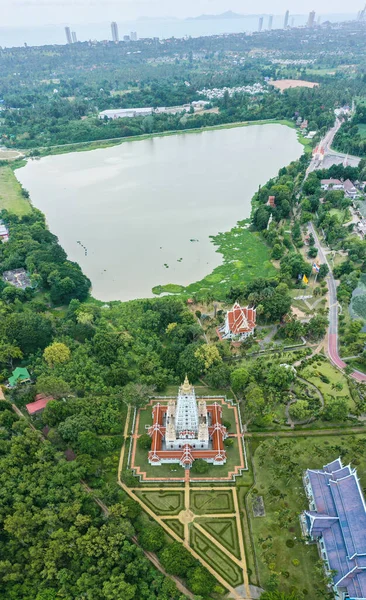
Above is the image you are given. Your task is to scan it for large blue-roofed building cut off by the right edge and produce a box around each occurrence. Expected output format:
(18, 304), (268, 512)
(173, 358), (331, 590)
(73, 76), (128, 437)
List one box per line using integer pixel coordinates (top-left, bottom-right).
(303, 459), (366, 600)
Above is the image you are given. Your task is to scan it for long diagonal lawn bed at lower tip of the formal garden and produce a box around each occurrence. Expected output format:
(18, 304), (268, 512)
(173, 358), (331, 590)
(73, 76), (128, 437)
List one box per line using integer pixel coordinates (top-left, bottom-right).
(190, 524), (243, 587)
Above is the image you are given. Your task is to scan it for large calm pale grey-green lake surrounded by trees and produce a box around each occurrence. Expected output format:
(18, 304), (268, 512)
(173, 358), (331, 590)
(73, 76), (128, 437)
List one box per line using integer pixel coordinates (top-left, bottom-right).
(16, 124), (303, 301)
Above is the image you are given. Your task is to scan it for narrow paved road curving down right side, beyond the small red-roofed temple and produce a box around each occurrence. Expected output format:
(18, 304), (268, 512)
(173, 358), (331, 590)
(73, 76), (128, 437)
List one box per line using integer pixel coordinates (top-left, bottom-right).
(308, 223), (366, 381)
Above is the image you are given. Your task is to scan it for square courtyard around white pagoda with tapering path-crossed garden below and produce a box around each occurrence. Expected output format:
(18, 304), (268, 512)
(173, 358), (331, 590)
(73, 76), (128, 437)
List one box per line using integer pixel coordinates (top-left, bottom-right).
(119, 381), (257, 600)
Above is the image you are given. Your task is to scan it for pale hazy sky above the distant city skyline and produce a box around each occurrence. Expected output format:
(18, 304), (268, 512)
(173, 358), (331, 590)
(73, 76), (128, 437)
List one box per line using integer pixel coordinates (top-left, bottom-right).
(0, 0), (364, 27)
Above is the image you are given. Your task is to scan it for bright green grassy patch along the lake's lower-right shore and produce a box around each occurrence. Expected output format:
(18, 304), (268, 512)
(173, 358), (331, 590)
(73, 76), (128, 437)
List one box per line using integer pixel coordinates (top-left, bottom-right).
(153, 221), (276, 300)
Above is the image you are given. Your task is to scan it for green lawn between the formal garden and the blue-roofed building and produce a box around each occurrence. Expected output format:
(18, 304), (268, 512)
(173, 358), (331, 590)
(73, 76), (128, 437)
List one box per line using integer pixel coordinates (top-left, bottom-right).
(248, 433), (366, 599)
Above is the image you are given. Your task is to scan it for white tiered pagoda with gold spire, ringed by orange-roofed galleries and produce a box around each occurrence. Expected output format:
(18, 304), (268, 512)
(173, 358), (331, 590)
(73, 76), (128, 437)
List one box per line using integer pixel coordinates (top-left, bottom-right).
(148, 377), (227, 469)
